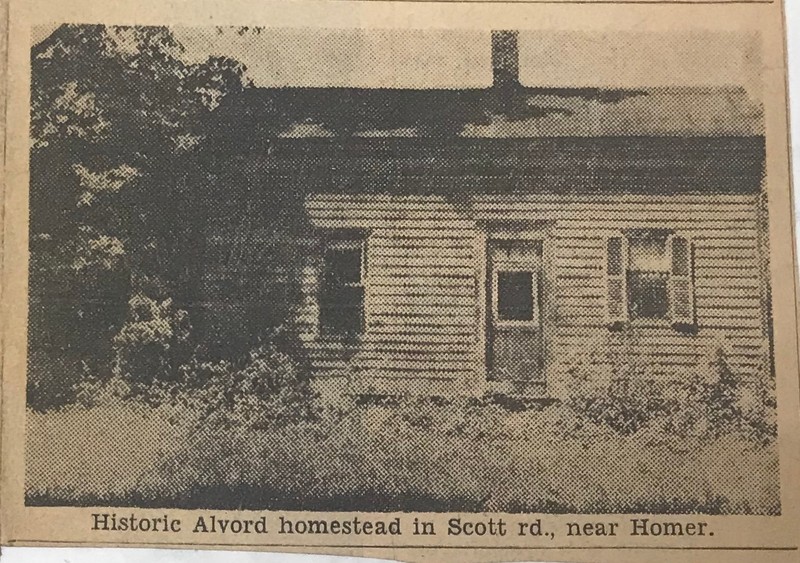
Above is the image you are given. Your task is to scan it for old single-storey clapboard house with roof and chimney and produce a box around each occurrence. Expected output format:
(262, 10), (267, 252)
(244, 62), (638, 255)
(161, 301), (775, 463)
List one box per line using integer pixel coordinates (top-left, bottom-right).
(198, 32), (771, 397)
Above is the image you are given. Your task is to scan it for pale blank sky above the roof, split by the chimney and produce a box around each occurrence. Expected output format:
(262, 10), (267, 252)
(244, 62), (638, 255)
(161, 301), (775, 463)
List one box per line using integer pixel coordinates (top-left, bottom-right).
(175, 28), (760, 97)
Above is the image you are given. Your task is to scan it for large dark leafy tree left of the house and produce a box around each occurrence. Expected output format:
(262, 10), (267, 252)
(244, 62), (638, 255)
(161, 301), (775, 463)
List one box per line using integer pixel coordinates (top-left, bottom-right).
(29, 25), (246, 408)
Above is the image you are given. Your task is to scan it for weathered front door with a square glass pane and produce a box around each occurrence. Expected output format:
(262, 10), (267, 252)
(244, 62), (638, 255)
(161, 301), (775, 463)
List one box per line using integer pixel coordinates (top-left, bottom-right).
(486, 240), (544, 383)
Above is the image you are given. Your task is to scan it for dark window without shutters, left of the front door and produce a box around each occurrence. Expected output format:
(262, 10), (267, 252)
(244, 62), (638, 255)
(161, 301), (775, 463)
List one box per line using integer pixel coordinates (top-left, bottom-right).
(319, 240), (364, 338)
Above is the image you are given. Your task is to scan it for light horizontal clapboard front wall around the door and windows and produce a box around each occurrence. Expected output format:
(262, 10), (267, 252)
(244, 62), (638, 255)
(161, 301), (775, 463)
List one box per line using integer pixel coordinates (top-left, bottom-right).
(297, 194), (768, 396)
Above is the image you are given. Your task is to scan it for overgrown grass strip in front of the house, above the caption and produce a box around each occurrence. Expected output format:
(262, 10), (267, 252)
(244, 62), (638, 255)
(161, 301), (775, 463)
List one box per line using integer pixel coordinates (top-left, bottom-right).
(26, 400), (780, 514)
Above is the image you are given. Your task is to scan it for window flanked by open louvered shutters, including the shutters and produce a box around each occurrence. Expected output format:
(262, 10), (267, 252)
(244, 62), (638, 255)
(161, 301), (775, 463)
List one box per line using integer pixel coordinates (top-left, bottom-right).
(606, 230), (694, 325)
